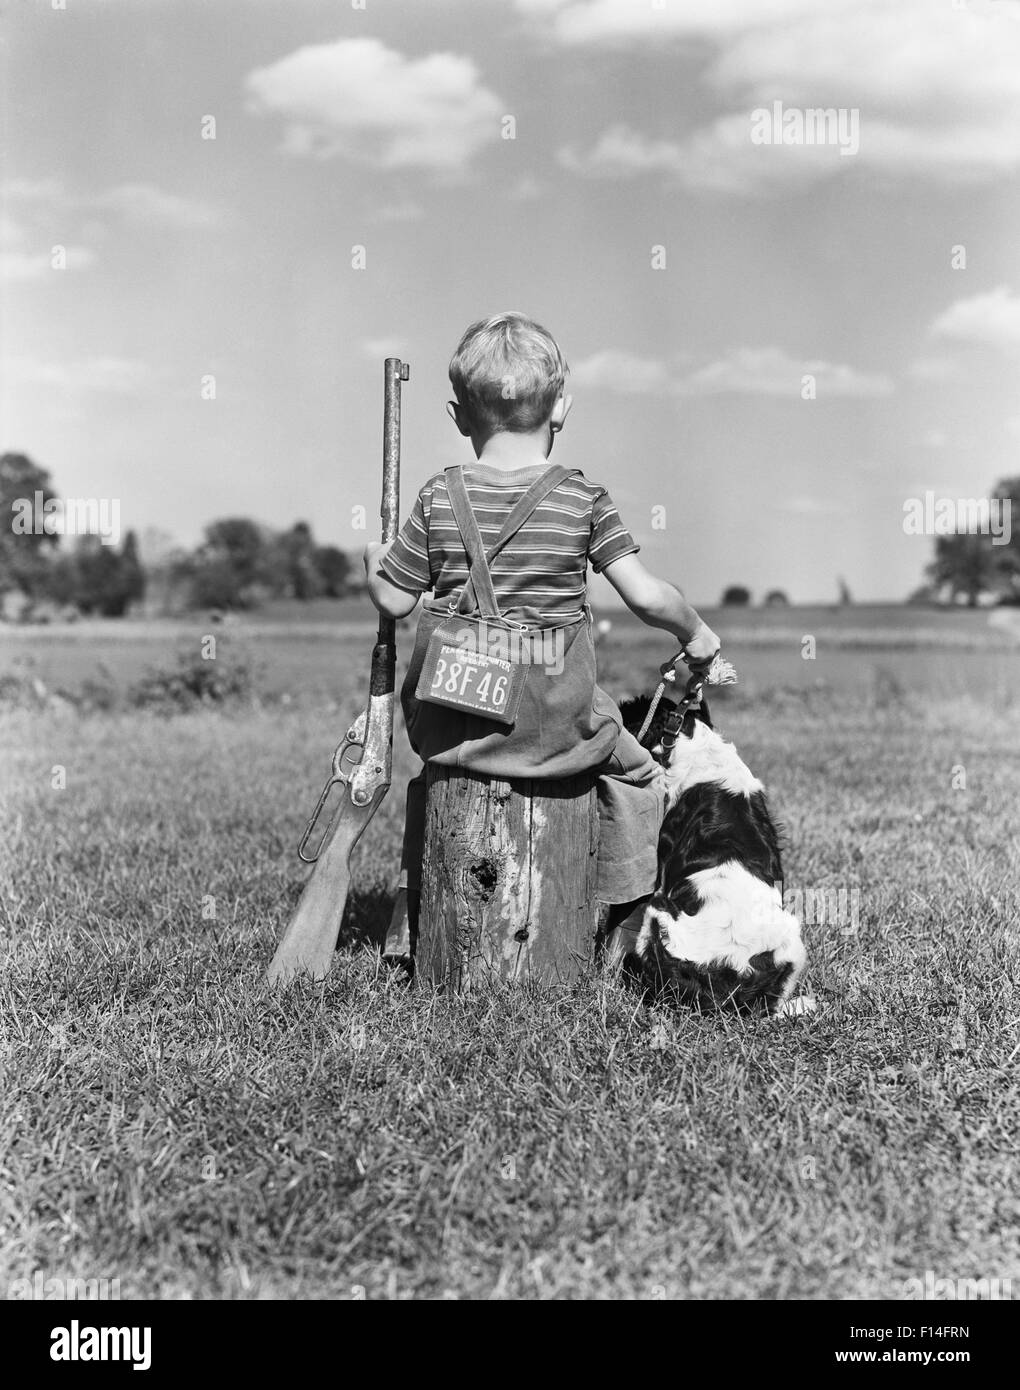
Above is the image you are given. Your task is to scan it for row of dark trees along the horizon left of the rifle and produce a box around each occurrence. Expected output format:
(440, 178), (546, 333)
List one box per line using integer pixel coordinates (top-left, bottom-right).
(0, 453), (361, 617)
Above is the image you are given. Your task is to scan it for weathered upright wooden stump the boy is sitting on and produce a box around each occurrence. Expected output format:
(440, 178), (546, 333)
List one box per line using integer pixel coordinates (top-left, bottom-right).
(414, 766), (599, 991)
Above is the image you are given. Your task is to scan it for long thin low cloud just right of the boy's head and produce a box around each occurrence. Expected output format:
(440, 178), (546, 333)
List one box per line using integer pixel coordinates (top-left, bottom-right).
(571, 348), (895, 400)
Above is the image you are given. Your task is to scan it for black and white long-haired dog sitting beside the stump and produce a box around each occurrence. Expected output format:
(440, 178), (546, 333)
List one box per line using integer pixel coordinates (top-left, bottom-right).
(620, 696), (810, 1013)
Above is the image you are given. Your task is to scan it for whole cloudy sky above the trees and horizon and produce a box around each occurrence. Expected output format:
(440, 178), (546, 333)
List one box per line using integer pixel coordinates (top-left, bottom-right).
(0, 0), (1020, 603)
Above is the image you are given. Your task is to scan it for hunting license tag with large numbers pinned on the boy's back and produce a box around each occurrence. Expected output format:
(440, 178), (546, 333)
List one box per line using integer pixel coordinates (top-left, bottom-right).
(414, 620), (528, 724)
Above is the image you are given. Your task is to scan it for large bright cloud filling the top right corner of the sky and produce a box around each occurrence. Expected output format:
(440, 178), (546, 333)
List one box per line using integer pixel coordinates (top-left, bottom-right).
(544, 0), (1020, 195)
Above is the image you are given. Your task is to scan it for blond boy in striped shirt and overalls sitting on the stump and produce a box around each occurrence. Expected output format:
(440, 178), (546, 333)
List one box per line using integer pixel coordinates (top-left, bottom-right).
(364, 313), (718, 956)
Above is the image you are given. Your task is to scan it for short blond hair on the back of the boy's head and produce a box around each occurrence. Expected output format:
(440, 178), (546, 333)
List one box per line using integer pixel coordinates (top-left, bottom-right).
(450, 313), (570, 434)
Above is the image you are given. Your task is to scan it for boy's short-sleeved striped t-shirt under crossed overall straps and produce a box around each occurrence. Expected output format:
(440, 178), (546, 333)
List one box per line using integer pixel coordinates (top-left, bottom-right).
(379, 463), (639, 619)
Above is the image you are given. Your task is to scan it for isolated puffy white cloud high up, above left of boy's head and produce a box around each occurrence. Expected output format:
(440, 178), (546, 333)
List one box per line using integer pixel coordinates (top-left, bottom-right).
(245, 39), (503, 175)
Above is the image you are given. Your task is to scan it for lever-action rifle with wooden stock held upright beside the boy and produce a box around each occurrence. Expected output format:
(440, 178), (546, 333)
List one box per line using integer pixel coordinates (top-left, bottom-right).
(268, 357), (410, 984)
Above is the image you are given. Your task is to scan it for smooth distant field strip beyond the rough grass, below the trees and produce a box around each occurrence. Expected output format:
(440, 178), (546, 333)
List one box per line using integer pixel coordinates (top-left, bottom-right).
(0, 600), (1020, 703)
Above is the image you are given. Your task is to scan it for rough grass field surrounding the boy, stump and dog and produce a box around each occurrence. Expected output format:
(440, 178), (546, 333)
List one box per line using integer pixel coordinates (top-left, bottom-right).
(0, 610), (1020, 1298)
